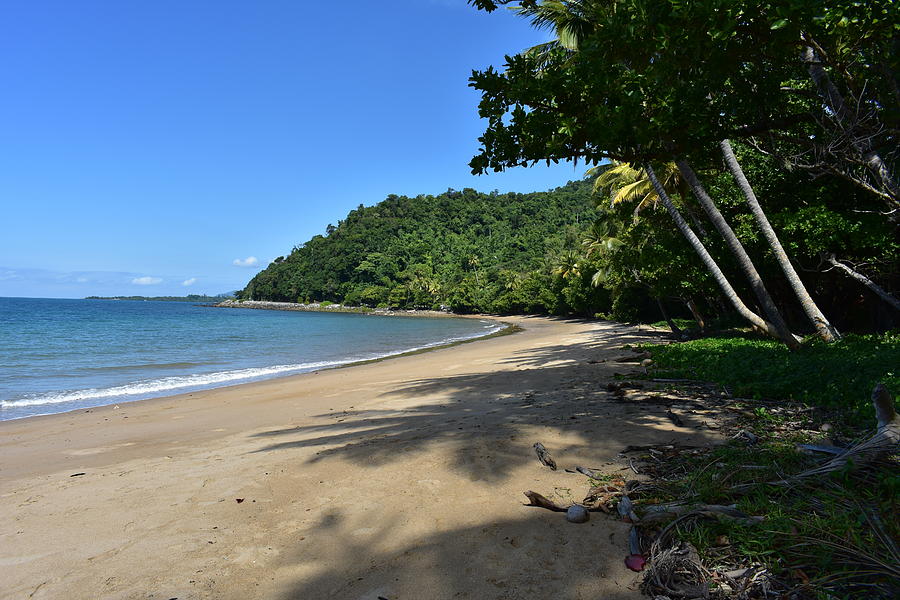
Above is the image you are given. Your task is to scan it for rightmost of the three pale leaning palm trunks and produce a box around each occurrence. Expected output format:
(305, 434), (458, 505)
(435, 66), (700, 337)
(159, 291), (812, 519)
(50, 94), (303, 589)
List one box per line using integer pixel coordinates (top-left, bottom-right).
(719, 140), (840, 342)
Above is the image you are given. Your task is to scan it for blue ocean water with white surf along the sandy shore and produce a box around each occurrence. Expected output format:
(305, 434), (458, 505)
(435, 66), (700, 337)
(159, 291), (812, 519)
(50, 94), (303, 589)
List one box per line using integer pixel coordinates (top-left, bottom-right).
(0, 298), (501, 420)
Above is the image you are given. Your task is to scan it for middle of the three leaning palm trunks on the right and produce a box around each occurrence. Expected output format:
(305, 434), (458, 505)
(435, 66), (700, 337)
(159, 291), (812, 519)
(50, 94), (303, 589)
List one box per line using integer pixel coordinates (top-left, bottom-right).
(675, 159), (800, 350)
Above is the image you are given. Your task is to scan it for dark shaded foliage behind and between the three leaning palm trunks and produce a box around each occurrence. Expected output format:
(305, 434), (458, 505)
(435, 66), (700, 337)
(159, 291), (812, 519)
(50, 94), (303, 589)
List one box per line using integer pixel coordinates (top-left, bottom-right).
(594, 144), (900, 334)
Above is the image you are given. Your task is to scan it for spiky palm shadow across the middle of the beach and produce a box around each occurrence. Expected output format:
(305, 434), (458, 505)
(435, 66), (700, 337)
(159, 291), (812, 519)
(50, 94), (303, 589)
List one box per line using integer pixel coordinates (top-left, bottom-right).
(248, 327), (702, 483)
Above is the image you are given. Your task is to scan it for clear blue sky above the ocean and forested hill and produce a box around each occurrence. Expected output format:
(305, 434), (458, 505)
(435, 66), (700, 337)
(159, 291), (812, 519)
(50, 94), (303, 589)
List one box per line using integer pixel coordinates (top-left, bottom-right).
(0, 0), (582, 298)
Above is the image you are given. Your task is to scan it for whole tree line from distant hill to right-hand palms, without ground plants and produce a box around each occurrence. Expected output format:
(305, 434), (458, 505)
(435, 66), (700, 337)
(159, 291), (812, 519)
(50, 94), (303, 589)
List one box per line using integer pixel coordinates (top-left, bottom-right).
(240, 0), (900, 338)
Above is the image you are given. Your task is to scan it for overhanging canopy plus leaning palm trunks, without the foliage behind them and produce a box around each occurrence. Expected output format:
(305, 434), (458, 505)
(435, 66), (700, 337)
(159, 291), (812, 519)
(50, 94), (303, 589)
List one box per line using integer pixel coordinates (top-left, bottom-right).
(470, 0), (900, 340)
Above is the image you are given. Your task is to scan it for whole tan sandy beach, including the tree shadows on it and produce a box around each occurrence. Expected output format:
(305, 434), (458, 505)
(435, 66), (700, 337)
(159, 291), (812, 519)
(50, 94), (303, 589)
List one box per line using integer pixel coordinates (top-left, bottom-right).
(0, 317), (711, 600)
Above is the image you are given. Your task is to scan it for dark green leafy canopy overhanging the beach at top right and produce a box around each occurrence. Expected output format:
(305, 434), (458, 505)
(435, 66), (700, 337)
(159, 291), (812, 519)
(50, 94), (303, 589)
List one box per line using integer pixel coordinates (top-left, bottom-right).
(470, 0), (900, 208)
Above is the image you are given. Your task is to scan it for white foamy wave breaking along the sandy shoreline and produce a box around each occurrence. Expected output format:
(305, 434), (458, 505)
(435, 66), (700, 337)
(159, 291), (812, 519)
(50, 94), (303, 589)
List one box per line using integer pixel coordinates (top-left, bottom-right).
(0, 321), (503, 408)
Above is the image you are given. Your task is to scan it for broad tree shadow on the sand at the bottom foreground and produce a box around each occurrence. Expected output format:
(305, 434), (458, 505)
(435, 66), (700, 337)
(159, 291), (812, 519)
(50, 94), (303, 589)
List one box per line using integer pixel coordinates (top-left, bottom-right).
(277, 508), (640, 600)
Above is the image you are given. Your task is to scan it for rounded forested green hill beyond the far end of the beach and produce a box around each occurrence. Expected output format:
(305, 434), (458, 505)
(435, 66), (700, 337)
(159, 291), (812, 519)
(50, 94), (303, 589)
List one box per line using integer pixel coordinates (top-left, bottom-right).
(239, 181), (606, 313)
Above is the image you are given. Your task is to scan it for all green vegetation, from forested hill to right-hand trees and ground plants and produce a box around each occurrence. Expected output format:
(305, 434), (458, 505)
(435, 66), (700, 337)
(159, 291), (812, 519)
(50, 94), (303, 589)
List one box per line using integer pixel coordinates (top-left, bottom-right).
(237, 0), (900, 599)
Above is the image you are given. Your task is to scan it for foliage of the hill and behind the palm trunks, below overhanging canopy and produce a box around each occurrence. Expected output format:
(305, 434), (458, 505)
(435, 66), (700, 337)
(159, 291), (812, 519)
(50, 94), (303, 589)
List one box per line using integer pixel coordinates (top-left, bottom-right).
(238, 140), (900, 333)
